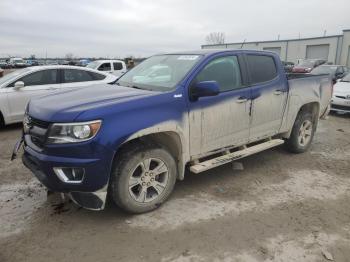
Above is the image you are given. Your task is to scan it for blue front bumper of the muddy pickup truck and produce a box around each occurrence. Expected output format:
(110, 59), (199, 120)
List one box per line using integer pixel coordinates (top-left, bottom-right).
(22, 140), (113, 210)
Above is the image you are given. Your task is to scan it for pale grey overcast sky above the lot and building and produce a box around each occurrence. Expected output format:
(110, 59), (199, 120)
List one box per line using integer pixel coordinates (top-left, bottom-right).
(0, 0), (350, 58)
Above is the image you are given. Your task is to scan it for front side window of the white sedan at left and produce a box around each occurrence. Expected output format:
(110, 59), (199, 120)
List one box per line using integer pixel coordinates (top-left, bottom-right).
(9, 69), (57, 87)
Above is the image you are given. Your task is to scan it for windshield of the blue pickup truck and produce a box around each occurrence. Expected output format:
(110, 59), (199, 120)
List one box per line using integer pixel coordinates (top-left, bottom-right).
(117, 55), (201, 91)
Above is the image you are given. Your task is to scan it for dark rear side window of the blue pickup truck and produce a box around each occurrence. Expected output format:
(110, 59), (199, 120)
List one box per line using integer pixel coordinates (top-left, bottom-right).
(247, 55), (277, 84)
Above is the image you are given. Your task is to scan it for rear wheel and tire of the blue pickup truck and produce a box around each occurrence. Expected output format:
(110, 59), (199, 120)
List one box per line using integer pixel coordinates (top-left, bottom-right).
(285, 112), (316, 154)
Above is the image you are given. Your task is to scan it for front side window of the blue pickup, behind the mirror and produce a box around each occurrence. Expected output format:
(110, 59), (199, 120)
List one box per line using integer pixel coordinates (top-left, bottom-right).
(195, 56), (242, 92)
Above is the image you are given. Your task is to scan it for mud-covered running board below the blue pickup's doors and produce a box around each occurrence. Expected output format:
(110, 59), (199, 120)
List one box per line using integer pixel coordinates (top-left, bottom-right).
(190, 139), (284, 174)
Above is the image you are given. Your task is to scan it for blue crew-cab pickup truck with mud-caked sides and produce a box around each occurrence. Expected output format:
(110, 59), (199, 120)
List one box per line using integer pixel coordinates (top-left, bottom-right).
(14, 50), (332, 213)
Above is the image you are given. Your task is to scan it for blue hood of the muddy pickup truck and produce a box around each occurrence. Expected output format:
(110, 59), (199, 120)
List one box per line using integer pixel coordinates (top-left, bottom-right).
(28, 84), (158, 122)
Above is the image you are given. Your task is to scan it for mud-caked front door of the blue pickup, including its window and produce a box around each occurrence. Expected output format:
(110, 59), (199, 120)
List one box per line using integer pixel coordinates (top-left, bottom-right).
(189, 55), (250, 156)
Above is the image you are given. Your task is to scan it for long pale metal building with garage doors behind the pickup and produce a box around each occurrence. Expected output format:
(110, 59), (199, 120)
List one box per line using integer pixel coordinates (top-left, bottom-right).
(202, 29), (350, 67)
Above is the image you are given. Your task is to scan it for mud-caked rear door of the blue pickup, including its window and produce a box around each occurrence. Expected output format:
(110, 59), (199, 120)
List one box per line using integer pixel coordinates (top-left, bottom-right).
(245, 53), (288, 141)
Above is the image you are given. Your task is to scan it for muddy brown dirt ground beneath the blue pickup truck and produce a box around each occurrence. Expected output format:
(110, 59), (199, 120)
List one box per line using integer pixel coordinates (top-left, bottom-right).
(0, 115), (350, 262)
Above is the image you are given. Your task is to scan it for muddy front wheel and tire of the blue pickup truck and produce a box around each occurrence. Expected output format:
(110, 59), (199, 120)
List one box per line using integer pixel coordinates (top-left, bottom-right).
(110, 144), (177, 213)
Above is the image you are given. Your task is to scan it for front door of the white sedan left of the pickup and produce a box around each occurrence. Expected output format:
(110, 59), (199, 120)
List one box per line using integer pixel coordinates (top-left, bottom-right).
(7, 69), (60, 122)
